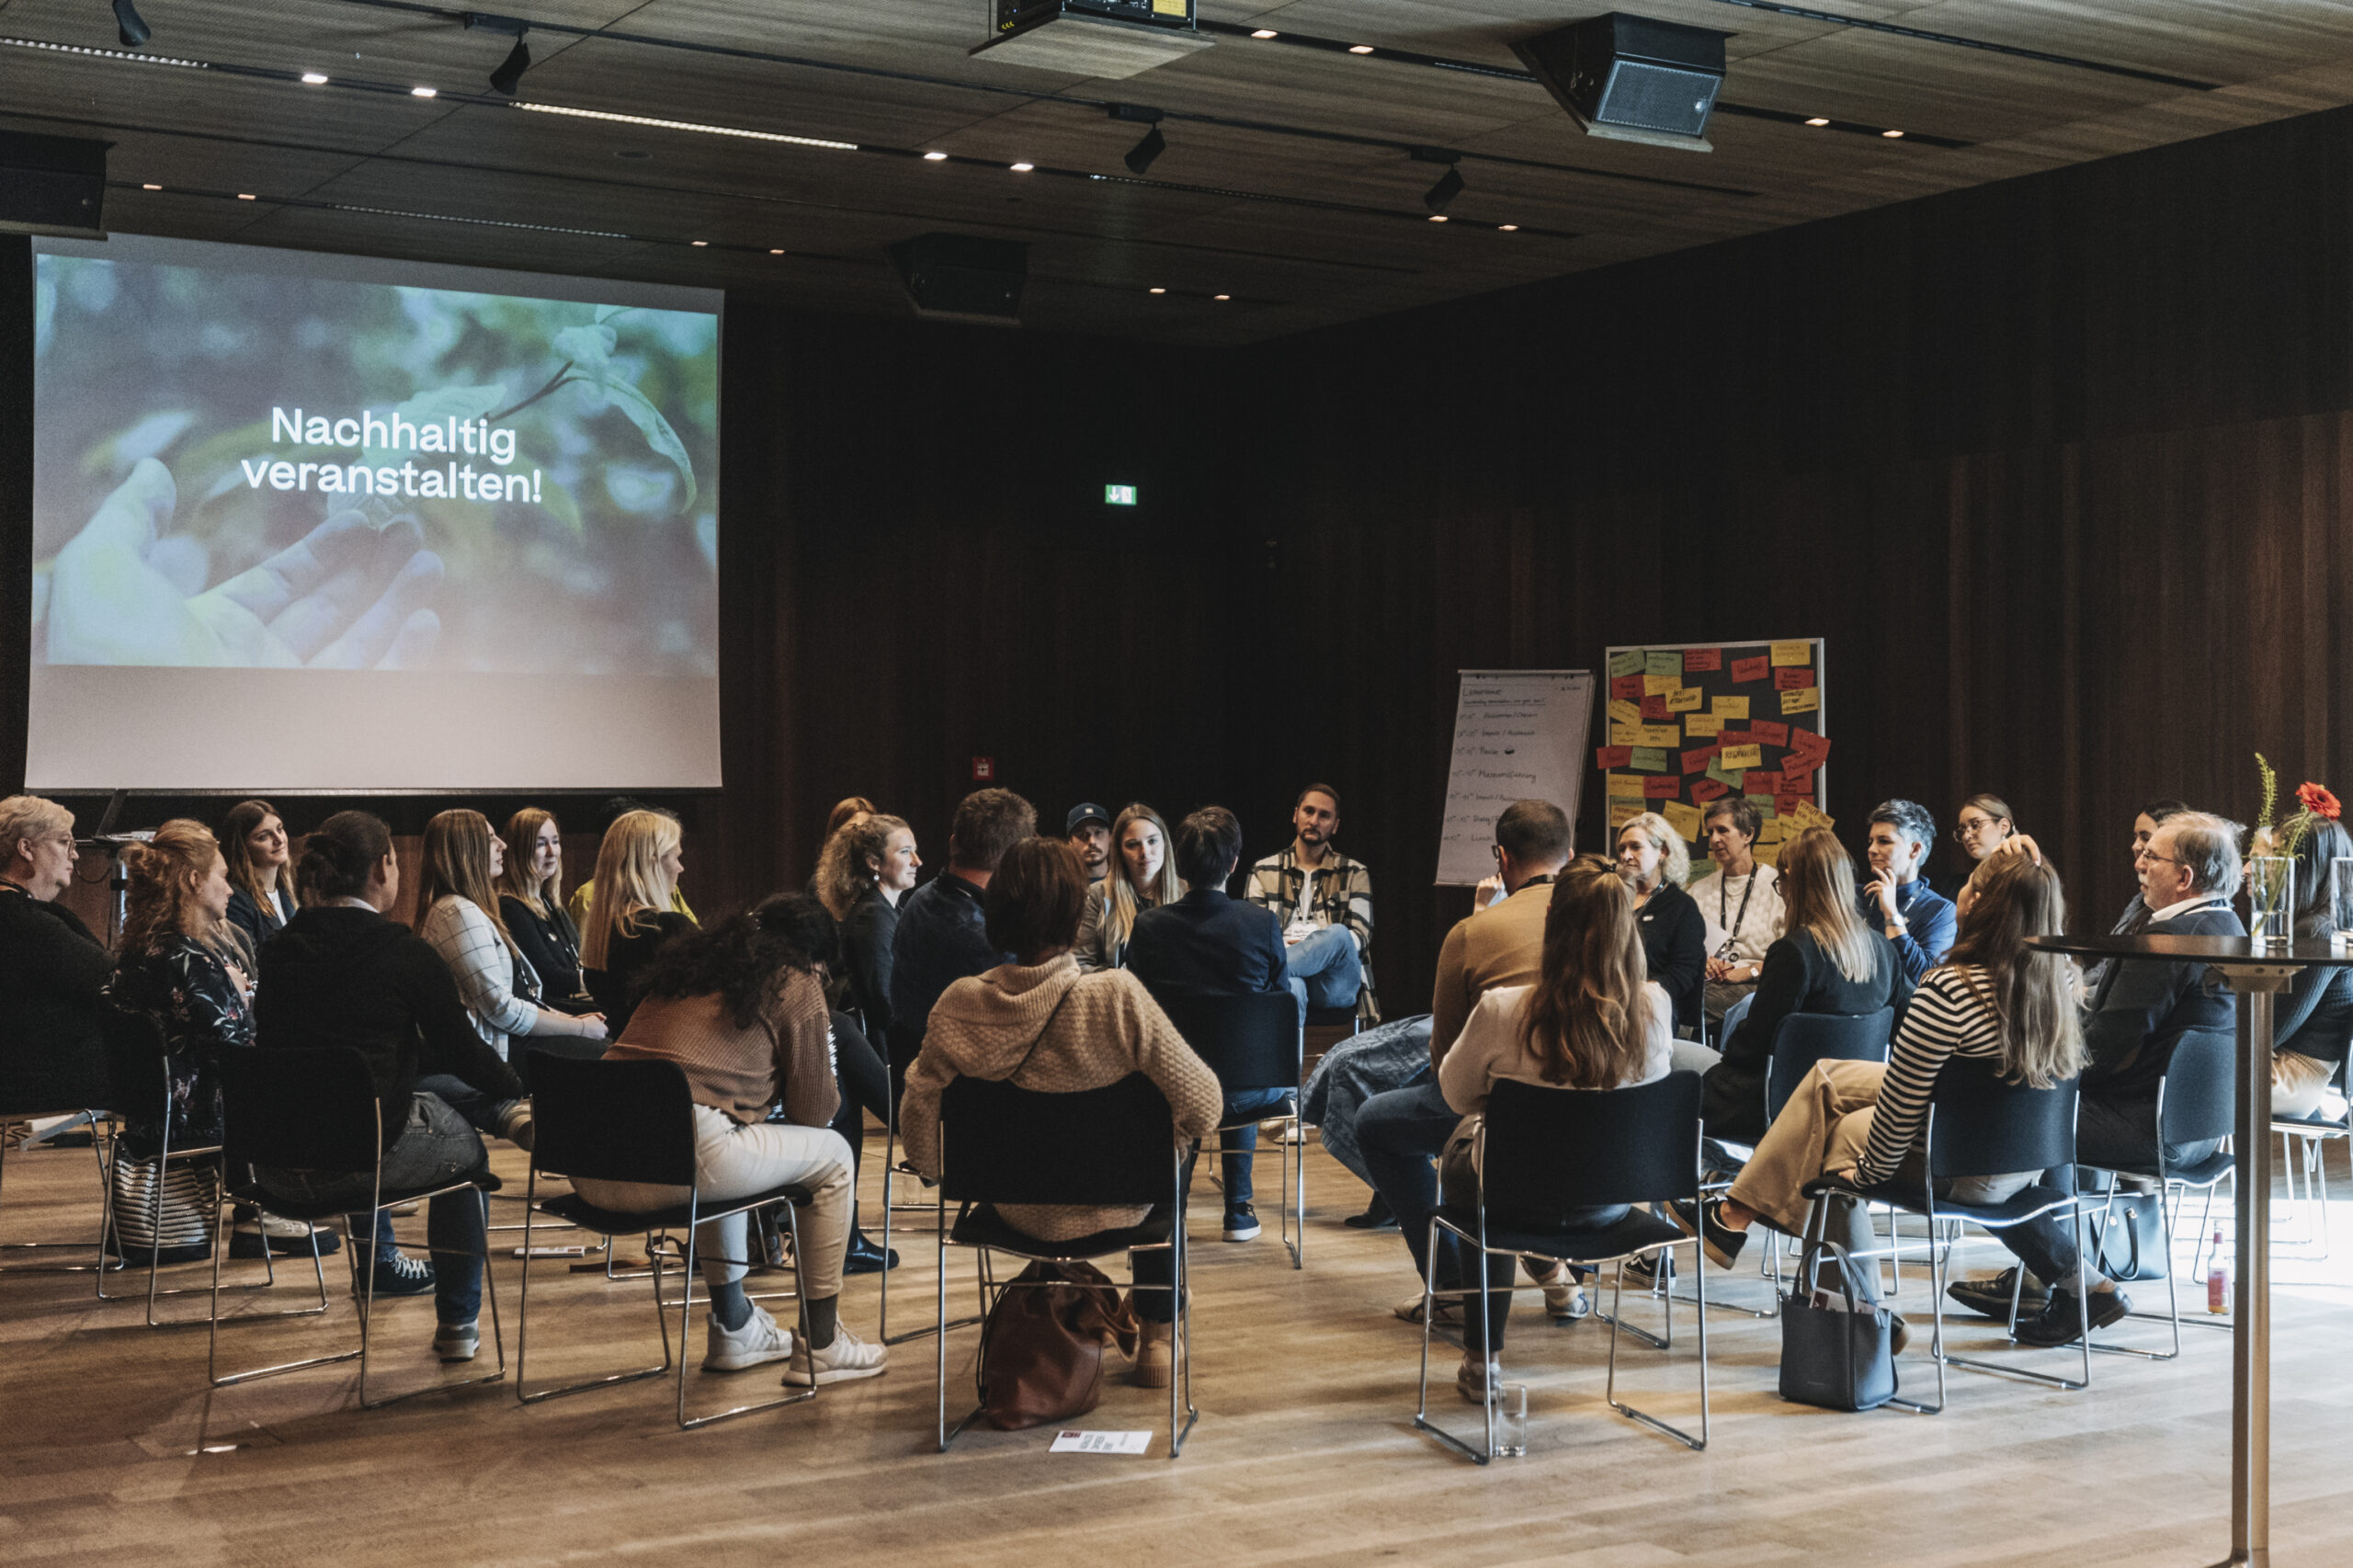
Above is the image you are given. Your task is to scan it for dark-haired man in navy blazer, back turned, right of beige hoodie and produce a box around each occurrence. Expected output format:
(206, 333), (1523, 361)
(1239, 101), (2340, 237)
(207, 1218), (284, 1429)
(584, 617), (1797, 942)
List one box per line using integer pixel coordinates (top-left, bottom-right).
(1127, 805), (1306, 1241)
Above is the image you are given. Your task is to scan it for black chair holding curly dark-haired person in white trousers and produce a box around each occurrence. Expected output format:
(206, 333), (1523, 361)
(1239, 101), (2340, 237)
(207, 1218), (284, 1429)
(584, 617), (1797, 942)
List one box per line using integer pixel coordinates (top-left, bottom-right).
(516, 1052), (816, 1431)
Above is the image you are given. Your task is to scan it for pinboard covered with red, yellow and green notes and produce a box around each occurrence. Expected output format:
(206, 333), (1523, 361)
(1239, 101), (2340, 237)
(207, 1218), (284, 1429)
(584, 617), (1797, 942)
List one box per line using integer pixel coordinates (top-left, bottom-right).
(1593, 638), (1831, 864)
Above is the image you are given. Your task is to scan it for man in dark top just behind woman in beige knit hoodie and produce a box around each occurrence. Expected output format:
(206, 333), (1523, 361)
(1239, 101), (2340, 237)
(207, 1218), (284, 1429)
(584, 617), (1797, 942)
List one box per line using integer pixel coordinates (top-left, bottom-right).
(890, 789), (1038, 1102)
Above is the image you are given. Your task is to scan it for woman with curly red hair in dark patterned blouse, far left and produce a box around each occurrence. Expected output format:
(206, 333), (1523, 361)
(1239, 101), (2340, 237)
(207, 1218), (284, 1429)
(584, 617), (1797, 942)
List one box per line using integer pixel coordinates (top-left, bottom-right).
(108, 817), (341, 1265)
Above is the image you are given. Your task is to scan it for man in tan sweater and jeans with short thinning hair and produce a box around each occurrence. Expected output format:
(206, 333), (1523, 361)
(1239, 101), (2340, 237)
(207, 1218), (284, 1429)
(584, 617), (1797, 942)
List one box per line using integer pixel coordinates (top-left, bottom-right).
(1303, 801), (1570, 1229)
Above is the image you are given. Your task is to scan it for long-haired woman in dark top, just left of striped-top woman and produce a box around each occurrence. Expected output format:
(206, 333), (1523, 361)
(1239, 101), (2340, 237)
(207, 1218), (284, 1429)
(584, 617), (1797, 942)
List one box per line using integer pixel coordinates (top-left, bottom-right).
(1676, 826), (1911, 1144)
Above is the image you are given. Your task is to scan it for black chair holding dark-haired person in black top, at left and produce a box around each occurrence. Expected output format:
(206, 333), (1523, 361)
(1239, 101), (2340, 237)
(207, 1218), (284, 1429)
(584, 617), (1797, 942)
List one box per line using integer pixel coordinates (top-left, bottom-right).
(205, 1045), (506, 1410)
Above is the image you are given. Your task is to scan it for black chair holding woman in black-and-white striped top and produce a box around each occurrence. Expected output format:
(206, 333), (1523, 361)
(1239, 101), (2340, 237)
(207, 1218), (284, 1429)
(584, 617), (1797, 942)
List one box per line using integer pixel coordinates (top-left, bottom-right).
(1805, 1057), (2097, 1415)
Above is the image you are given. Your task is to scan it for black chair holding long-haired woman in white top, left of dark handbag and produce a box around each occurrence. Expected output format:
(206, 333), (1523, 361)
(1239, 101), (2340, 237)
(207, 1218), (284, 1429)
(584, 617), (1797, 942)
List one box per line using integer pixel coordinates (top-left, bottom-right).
(1415, 1074), (1709, 1464)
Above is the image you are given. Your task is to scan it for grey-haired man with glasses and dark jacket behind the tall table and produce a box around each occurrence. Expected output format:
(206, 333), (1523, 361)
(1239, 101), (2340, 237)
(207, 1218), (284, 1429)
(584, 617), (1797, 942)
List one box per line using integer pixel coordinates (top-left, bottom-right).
(1946, 812), (2247, 1345)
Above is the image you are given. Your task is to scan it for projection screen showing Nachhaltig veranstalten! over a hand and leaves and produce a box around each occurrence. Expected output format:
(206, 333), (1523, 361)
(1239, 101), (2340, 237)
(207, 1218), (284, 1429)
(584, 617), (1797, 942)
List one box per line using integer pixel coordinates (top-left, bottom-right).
(26, 238), (720, 793)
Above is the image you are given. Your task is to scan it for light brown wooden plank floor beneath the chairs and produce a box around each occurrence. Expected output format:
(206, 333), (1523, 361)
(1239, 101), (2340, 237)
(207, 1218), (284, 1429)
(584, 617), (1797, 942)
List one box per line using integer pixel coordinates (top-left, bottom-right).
(0, 1140), (2353, 1568)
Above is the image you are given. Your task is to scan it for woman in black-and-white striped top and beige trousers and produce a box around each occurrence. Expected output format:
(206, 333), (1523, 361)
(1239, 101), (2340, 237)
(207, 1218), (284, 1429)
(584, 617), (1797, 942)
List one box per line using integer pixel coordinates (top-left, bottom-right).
(1676, 855), (2131, 1349)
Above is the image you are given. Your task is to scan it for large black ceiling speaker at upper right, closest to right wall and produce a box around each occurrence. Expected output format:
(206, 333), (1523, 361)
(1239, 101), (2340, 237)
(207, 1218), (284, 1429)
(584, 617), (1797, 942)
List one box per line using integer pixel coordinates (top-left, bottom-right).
(1511, 12), (1732, 153)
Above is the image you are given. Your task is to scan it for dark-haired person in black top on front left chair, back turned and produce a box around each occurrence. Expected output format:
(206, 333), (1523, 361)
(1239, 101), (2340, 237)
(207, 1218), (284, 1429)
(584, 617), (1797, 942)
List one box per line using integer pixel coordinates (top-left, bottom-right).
(254, 812), (532, 1361)
